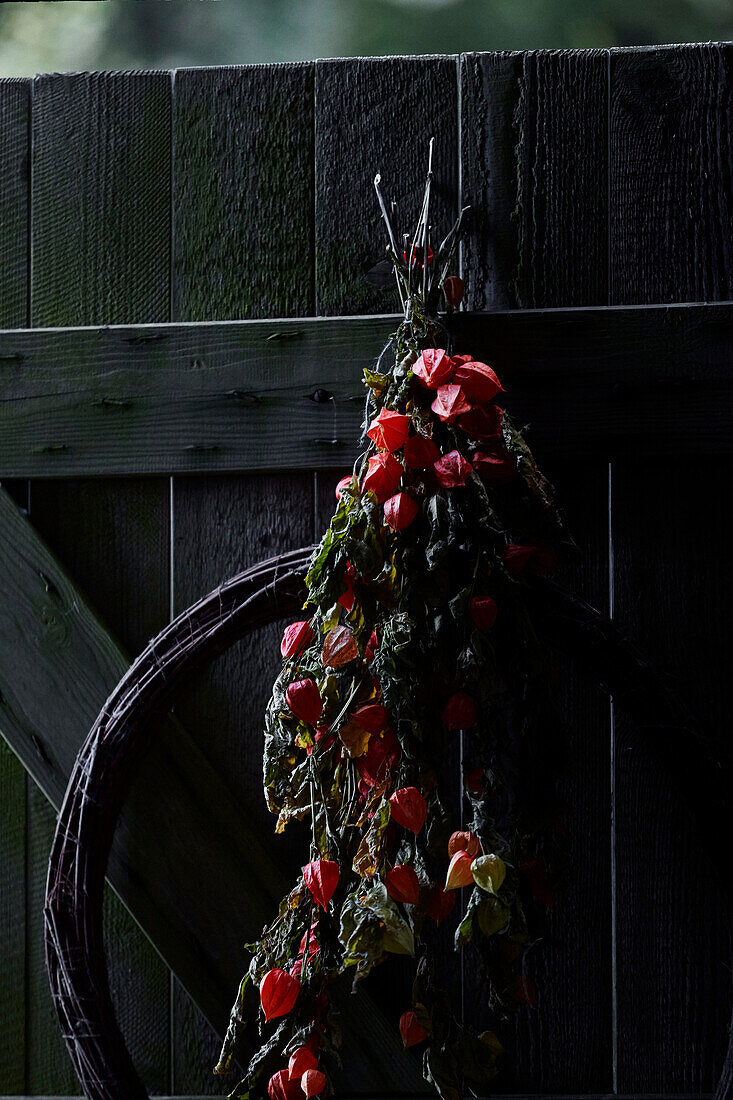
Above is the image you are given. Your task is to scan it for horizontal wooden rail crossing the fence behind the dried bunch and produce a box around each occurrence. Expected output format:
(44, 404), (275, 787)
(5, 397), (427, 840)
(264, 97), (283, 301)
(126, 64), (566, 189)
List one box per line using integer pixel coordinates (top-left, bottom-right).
(0, 304), (733, 477)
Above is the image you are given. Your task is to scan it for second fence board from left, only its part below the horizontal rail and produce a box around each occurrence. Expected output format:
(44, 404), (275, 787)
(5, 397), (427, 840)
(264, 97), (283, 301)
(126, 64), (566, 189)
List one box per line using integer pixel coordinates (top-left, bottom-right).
(30, 479), (169, 1091)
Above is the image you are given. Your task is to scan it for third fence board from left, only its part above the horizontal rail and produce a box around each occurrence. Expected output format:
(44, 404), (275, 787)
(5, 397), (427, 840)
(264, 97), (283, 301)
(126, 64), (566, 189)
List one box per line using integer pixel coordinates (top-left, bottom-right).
(173, 64), (314, 321)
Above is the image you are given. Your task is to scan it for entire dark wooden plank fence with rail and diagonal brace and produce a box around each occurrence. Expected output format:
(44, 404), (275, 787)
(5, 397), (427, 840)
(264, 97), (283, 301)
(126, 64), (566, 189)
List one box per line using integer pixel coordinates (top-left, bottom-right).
(0, 45), (733, 1100)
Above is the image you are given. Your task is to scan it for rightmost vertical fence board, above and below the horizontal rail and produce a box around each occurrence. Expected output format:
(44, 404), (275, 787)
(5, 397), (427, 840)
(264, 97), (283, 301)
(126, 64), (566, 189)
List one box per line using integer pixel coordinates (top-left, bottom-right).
(611, 40), (733, 1091)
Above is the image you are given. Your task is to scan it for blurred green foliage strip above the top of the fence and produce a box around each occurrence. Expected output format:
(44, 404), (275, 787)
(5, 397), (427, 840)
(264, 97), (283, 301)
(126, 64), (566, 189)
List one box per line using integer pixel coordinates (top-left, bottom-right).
(0, 0), (733, 76)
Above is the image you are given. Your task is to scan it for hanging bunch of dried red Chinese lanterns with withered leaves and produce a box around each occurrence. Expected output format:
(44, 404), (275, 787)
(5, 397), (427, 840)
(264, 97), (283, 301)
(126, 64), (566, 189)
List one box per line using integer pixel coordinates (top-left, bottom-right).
(217, 141), (560, 1100)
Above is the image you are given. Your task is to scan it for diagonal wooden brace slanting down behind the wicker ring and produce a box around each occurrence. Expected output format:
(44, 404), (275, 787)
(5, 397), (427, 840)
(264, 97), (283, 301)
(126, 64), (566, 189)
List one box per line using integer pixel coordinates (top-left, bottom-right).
(0, 490), (424, 1092)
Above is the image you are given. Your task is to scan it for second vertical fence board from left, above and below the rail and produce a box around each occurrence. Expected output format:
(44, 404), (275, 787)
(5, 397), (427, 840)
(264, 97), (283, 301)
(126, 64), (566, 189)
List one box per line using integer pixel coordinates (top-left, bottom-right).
(29, 73), (171, 1092)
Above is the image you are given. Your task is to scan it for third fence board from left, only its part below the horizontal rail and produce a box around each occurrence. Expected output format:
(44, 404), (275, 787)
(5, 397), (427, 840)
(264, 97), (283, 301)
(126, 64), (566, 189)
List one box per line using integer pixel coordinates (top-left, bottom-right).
(173, 473), (314, 1095)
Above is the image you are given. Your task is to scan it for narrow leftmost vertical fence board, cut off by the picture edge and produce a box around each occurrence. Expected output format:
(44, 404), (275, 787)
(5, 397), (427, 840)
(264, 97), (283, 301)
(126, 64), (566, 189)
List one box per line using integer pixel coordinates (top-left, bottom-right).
(0, 80), (30, 1092)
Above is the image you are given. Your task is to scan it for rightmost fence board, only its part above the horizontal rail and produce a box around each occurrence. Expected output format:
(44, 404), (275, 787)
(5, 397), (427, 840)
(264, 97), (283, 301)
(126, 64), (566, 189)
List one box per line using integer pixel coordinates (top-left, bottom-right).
(611, 44), (733, 304)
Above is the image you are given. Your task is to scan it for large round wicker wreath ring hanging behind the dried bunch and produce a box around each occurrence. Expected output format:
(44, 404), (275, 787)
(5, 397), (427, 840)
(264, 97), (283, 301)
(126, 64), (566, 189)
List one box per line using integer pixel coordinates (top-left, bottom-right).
(44, 547), (733, 1100)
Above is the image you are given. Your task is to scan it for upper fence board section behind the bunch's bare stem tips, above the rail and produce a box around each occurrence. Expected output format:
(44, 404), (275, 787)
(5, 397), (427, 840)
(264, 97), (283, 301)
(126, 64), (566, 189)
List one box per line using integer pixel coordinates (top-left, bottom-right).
(315, 57), (458, 315)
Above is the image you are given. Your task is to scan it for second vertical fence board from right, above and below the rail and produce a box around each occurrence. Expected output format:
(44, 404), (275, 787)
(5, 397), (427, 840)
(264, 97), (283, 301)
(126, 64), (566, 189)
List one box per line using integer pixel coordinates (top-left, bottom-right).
(461, 51), (612, 1092)
